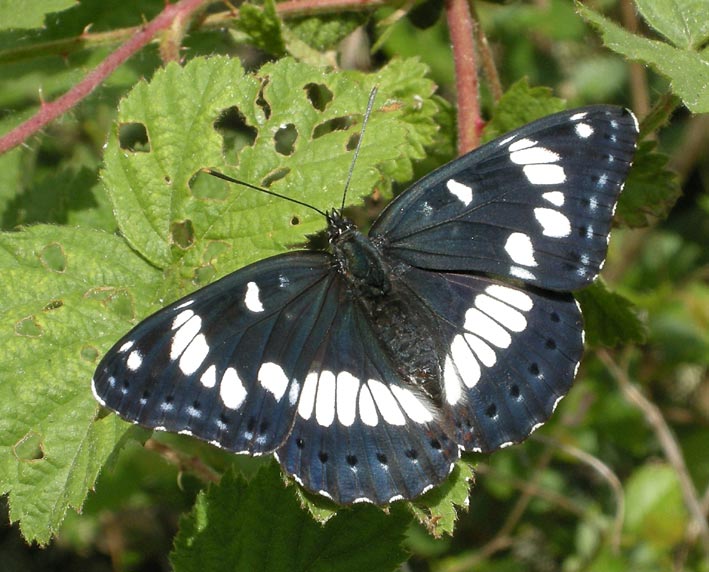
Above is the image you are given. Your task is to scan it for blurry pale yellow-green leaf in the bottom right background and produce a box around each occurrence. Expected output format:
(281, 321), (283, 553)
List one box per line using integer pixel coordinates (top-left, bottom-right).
(624, 464), (688, 549)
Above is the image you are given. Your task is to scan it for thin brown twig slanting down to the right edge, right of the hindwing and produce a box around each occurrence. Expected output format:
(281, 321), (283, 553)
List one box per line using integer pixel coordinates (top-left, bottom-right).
(598, 350), (709, 558)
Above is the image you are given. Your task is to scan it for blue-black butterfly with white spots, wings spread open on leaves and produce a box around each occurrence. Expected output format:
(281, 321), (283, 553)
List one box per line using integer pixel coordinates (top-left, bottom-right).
(93, 106), (638, 504)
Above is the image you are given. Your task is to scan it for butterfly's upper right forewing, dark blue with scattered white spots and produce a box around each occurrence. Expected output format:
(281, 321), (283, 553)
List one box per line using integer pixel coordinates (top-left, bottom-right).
(370, 106), (638, 291)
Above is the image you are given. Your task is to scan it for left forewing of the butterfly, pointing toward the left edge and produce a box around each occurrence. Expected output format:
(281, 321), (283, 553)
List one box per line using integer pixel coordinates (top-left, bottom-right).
(92, 252), (337, 454)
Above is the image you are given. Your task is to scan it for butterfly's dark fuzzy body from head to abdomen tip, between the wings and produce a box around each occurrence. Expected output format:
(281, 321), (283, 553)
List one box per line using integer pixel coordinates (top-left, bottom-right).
(328, 211), (442, 404)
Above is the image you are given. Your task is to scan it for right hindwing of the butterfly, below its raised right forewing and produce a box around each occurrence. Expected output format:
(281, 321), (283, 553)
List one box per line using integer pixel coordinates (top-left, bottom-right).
(396, 268), (583, 452)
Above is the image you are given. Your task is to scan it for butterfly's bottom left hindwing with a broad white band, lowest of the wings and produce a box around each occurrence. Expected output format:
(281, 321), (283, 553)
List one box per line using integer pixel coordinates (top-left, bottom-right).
(278, 294), (459, 505)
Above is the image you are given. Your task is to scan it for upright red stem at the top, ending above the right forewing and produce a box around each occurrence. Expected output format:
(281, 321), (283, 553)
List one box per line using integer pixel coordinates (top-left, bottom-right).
(446, 0), (483, 155)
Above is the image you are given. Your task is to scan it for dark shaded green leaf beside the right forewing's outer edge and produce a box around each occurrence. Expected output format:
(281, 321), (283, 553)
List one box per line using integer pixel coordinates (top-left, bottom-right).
(615, 141), (681, 228)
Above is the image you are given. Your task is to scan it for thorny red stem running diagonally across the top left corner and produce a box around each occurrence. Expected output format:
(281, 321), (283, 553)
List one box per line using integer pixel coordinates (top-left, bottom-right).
(0, 0), (208, 154)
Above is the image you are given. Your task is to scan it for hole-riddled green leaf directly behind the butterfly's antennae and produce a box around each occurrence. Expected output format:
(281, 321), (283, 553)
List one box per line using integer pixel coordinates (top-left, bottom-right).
(103, 58), (437, 282)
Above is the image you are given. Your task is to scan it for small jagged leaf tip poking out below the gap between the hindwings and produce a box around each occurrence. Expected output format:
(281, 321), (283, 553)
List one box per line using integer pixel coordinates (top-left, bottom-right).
(410, 461), (475, 538)
